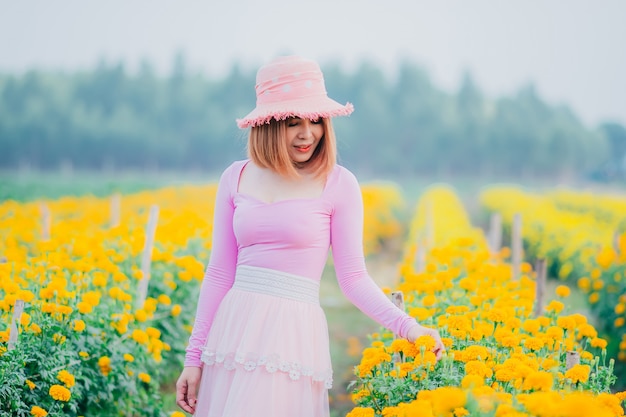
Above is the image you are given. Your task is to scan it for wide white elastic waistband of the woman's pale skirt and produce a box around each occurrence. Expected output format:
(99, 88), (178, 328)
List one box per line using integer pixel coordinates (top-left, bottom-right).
(233, 265), (320, 304)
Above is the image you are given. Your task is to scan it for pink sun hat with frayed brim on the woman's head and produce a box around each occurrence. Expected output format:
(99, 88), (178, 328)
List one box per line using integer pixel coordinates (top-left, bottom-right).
(237, 56), (354, 129)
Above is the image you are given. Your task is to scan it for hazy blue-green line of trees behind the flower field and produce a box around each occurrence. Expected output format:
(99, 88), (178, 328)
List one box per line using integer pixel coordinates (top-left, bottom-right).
(0, 56), (626, 177)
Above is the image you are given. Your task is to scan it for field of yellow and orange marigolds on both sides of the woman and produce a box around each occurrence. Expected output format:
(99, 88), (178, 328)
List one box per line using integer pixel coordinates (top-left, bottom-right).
(0, 183), (626, 417)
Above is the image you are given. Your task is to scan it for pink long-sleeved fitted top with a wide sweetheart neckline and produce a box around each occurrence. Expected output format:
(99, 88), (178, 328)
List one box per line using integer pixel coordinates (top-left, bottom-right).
(185, 160), (416, 366)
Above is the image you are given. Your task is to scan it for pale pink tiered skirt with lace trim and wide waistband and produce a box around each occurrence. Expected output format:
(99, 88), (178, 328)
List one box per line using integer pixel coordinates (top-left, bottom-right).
(194, 266), (332, 417)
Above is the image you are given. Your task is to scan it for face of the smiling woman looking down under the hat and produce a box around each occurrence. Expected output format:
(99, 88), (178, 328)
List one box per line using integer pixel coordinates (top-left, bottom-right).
(286, 117), (324, 164)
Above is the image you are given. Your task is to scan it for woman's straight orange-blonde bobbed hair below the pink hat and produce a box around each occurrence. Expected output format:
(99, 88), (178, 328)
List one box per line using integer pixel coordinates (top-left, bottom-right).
(248, 118), (337, 178)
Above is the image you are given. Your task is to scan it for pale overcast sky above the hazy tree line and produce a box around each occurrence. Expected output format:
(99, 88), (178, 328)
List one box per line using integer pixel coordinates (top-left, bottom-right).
(0, 0), (626, 125)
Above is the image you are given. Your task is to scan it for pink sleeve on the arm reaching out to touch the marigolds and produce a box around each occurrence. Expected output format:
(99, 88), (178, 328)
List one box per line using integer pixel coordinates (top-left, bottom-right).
(331, 169), (417, 337)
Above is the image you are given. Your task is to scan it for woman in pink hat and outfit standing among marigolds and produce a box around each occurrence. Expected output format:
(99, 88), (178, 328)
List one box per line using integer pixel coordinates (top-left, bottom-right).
(176, 56), (444, 417)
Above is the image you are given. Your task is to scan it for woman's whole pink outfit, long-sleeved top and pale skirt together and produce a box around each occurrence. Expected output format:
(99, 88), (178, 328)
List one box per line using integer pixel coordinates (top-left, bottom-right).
(185, 160), (416, 417)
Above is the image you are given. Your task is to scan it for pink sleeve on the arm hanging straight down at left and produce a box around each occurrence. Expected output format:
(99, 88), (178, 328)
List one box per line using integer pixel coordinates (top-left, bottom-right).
(185, 164), (237, 366)
